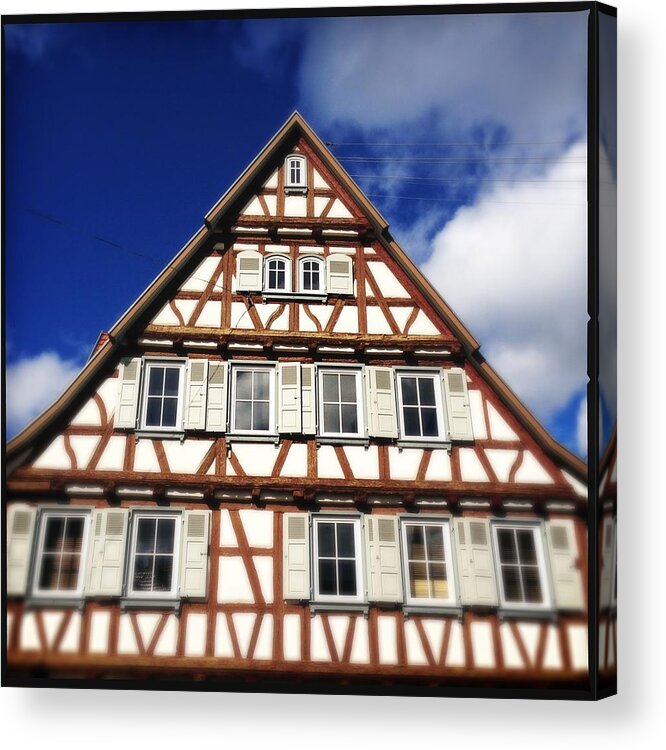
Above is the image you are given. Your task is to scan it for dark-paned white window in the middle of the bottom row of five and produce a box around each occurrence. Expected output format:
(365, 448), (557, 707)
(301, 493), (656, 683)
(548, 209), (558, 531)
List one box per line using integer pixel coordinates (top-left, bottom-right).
(313, 517), (363, 602)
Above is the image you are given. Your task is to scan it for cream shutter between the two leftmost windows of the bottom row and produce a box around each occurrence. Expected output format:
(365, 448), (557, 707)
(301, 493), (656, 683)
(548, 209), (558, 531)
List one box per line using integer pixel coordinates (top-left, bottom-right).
(85, 508), (129, 596)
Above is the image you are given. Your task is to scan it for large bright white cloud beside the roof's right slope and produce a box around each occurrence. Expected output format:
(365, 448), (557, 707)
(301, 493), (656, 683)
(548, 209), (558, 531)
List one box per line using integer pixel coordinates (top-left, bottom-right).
(422, 144), (587, 418)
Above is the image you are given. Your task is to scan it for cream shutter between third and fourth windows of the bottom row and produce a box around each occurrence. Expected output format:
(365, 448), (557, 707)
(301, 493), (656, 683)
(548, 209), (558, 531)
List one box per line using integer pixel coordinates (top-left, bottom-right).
(363, 516), (402, 602)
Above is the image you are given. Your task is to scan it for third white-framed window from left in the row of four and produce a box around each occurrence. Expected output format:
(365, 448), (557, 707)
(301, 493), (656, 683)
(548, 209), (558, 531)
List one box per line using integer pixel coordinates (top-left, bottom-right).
(319, 368), (365, 437)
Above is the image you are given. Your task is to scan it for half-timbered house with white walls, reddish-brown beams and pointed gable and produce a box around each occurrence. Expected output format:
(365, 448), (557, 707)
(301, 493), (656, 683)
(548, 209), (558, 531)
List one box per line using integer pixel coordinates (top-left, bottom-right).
(6, 113), (588, 691)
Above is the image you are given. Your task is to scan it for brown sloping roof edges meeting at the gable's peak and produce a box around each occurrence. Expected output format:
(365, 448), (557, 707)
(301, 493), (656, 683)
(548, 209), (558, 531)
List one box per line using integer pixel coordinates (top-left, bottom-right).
(7, 112), (587, 478)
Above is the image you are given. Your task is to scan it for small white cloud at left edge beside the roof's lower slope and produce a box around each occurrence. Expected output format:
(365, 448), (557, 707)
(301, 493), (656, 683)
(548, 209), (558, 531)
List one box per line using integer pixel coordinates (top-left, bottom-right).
(5, 352), (80, 436)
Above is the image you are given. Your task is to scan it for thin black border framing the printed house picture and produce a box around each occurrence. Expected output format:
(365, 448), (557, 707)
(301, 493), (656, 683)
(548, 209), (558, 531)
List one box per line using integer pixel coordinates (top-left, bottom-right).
(0, 2), (617, 700)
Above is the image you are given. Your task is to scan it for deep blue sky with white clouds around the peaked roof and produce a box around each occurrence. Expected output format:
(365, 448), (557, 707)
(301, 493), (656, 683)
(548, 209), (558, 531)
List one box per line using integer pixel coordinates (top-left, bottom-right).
(4, 13), (587, 458)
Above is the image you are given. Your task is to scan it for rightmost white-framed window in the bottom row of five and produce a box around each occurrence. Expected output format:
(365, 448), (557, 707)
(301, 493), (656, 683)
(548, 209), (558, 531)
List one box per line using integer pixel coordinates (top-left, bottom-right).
(493, 524), (550, 608)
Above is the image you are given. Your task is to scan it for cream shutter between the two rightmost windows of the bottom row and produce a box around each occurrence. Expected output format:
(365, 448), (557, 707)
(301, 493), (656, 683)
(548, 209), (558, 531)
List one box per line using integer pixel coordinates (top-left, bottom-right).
(454, 518), (497, 607)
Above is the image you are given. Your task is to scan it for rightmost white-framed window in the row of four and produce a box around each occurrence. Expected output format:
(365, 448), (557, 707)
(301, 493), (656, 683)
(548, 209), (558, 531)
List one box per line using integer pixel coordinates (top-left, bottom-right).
(398, 372), (446, 440)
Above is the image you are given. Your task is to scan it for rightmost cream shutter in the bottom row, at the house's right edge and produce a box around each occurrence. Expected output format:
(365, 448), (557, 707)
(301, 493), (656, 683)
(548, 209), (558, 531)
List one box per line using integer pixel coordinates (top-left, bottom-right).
(546, 519), (585, 610)
